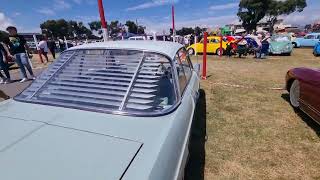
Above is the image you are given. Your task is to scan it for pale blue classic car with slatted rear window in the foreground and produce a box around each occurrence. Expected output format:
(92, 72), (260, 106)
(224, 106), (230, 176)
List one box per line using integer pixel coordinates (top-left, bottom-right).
(0, 41), (199, 180)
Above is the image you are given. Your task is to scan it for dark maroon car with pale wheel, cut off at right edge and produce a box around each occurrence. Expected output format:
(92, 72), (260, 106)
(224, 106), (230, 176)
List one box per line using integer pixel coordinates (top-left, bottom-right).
(286, 68), (320, 123)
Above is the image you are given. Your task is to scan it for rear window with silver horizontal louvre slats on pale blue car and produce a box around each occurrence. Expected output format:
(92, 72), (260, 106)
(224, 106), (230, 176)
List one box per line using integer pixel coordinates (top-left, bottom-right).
(15, 49), (177, 115)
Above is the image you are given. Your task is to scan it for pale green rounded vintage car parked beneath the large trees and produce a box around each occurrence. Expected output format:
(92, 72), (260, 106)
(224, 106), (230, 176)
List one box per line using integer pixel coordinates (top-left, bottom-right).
(269, 34), (293, 56)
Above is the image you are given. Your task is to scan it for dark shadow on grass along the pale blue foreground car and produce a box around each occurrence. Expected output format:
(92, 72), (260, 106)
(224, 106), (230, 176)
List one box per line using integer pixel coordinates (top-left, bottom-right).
(185, 89), (207, 180)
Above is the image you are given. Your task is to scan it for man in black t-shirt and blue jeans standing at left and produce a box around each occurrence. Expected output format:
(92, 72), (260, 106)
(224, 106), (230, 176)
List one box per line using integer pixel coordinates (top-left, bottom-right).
(7, 26), (35, 83)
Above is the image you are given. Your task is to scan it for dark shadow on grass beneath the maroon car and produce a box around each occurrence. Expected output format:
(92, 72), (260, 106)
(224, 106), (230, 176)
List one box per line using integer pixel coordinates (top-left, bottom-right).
(281, 93), (320, 137)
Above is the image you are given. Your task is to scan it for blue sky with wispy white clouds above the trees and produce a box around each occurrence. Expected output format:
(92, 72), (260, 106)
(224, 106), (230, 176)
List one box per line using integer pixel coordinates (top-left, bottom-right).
(0, 0), (320, 32)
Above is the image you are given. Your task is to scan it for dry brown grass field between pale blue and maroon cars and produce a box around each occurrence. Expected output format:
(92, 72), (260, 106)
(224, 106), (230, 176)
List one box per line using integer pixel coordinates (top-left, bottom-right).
(188, 49), (320, 179)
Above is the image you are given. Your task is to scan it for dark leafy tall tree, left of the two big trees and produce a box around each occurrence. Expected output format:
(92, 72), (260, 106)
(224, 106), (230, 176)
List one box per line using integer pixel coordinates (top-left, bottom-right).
(237, 0), (272, 33)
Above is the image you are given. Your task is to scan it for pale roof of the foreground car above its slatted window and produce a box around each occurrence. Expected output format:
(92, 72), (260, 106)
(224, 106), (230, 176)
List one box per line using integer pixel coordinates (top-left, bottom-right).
(69, 40), (183, 59)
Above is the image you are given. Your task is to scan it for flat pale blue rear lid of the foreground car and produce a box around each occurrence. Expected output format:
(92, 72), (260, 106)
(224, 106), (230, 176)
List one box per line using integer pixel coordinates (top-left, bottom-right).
(0, 114), (142, 180)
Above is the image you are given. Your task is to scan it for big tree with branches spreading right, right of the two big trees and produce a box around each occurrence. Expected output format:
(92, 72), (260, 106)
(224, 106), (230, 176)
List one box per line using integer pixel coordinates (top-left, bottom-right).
(266, 0), (307, 32)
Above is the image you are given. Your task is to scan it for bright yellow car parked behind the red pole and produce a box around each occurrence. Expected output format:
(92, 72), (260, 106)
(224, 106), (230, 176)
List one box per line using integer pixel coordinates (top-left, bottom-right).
(187, 36), (227, 55)
